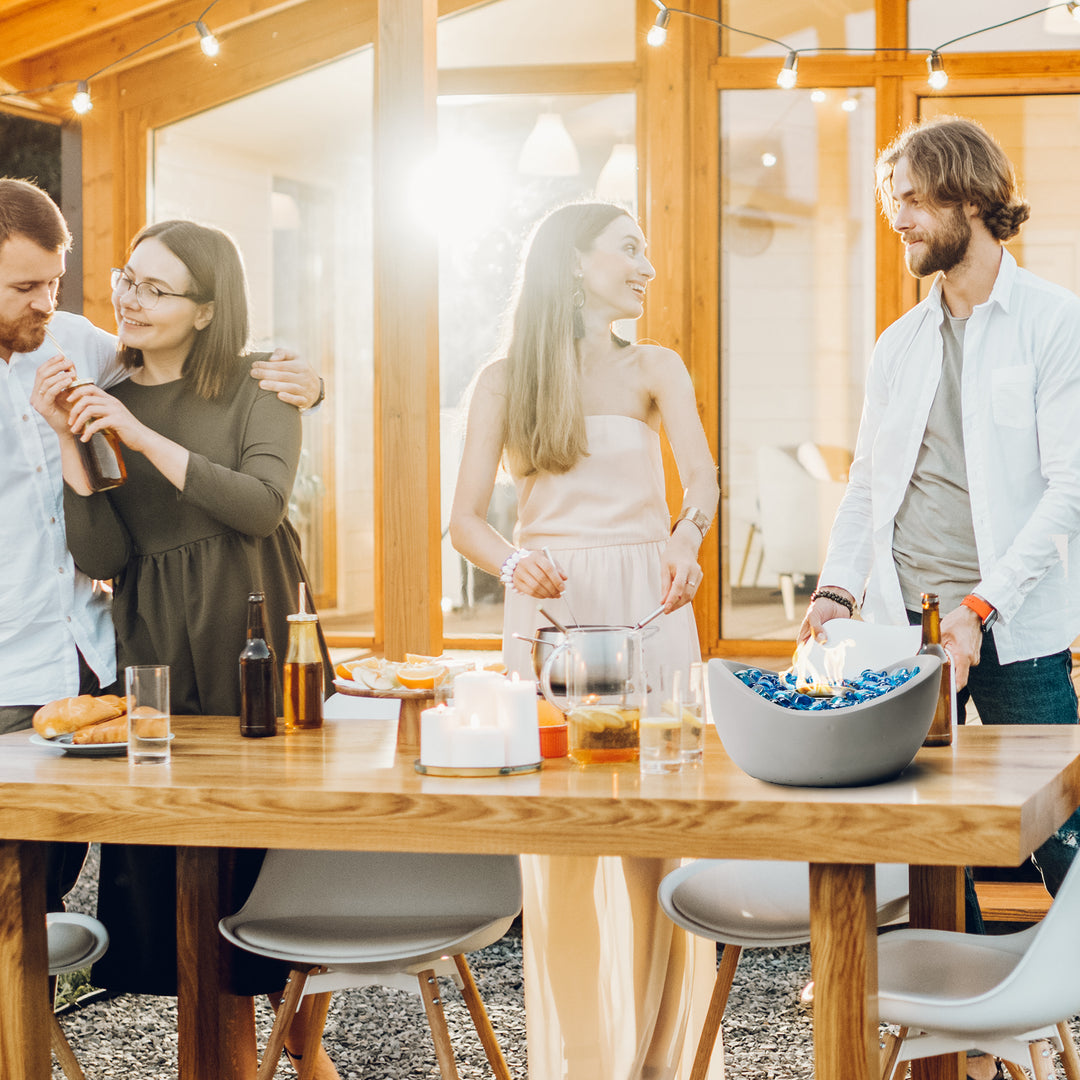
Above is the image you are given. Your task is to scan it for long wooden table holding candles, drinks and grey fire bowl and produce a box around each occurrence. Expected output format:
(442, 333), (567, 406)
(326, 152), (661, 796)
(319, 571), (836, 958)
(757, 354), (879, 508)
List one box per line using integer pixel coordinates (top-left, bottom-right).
(0, 717), (1080, 1080)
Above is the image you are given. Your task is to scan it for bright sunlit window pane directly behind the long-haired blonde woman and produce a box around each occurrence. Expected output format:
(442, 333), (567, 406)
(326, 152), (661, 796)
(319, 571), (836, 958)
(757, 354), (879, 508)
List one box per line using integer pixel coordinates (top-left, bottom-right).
(438, 94), (637, 636)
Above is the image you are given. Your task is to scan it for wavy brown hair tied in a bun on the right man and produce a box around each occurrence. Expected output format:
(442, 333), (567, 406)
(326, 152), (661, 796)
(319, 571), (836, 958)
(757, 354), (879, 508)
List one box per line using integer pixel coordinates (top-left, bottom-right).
(877, 117), (1031, 241)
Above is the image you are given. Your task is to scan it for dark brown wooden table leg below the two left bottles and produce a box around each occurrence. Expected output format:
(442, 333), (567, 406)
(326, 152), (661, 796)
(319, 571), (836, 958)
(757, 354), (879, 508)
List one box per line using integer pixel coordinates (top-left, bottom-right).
(176, 848), (257, 1080)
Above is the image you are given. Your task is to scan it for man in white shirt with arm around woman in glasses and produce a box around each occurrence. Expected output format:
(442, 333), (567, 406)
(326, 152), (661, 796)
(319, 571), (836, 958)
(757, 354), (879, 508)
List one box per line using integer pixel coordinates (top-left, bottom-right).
(0, 179), (321, 732)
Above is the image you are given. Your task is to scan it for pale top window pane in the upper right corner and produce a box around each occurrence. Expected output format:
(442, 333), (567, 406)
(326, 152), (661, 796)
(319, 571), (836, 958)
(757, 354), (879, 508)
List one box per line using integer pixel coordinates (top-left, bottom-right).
(907, 0), (1080, 53)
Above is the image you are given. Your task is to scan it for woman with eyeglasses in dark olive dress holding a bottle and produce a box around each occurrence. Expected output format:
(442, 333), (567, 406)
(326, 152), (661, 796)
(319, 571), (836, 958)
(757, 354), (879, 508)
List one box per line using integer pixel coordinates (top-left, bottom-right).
(34, 220), (337, 1080)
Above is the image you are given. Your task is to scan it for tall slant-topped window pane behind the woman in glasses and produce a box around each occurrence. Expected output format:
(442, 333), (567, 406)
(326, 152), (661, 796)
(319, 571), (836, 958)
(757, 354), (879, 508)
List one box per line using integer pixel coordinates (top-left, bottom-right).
(150, 50), (375, 633)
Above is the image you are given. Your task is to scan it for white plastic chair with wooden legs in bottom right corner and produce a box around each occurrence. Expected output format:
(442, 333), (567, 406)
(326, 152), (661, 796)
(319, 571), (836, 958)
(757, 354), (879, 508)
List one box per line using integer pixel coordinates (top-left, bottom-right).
(878, 846), (1080, 1080)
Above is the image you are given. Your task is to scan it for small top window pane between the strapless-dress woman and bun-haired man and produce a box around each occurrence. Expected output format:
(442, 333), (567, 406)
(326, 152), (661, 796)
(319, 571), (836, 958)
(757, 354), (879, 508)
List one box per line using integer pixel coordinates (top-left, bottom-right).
(721, 0), (875, 56)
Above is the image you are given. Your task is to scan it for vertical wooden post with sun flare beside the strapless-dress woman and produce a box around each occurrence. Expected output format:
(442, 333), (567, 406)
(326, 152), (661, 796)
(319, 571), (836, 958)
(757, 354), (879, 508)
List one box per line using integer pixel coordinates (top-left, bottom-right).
(373, 0), (442, 660)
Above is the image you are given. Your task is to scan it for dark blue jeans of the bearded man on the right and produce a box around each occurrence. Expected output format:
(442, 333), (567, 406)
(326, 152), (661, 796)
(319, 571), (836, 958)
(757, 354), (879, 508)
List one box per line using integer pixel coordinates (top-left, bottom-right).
(907, 611), (1080, 896)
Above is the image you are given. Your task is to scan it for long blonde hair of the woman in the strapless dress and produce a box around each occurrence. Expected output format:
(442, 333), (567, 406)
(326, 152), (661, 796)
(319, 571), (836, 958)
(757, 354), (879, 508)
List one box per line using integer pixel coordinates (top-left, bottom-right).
(504, 202), (630, 476)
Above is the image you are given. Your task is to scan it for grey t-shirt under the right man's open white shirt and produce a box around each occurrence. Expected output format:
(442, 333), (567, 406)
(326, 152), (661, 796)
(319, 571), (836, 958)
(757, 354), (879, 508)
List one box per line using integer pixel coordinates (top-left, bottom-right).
(892, 298), (982, 613)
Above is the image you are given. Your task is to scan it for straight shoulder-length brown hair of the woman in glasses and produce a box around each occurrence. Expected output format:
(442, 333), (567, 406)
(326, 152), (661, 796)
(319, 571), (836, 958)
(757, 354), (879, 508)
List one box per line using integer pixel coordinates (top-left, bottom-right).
(119, 220), (248, 401)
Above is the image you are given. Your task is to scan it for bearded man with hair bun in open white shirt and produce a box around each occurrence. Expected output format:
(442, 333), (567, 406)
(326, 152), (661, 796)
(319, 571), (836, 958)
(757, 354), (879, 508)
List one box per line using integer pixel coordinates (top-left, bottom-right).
(799, 118), (1080, 907)
